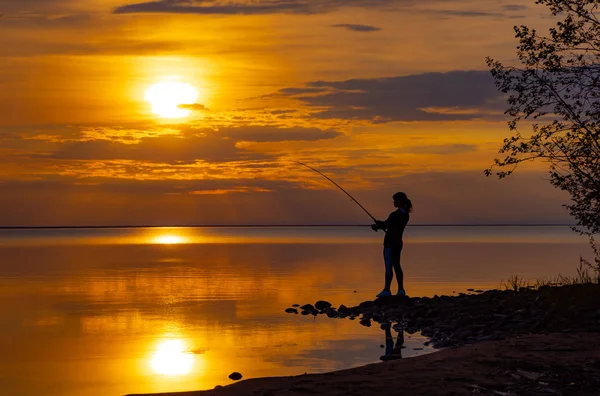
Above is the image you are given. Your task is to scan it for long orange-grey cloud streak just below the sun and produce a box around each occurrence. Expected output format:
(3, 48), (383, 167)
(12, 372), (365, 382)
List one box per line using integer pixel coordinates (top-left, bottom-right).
(15, 125), (342, 164)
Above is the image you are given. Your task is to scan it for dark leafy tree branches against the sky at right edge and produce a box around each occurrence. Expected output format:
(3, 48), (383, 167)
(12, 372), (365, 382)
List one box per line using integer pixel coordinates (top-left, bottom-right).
(485, 0), (600, 243)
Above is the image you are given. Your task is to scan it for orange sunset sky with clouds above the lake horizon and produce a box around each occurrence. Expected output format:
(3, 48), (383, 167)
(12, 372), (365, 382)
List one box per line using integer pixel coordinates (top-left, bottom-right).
(0, 0), (572, 226)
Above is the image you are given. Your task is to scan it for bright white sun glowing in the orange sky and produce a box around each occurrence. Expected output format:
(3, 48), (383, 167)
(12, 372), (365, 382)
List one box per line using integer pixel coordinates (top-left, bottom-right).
(144, 82), (198, 118)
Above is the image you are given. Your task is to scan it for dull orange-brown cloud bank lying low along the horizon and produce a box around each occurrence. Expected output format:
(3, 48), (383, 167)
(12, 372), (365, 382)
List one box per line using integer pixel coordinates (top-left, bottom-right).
(0, 169), (571, 225)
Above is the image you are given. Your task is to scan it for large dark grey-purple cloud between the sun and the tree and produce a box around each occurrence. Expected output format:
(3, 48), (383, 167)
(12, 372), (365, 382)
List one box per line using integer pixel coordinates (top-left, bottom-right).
(274, 71), (505, 123)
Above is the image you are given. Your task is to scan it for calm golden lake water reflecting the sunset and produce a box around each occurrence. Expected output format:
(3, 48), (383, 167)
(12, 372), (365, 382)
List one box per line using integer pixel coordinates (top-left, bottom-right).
(0, 227), (591, 396)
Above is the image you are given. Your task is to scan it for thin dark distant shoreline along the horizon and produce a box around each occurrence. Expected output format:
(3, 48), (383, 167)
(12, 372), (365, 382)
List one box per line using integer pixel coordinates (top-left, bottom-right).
(0, 224), (576, 230)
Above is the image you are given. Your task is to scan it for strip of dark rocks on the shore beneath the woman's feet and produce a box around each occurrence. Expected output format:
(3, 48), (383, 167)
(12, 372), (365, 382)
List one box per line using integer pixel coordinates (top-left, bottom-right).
(286, 284), (600, 348)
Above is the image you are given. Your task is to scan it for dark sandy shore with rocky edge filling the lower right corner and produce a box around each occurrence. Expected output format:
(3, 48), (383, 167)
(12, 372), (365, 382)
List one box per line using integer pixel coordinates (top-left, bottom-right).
(130, 284), (600, 396)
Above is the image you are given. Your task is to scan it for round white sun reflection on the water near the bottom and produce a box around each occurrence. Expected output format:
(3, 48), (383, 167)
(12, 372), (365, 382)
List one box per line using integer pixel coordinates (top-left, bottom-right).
(150, 340), (195, 376)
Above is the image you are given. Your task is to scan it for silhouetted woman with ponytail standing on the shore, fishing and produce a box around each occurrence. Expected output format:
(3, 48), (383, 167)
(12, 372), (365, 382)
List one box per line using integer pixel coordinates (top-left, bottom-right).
(371, 192), (412, 297)
